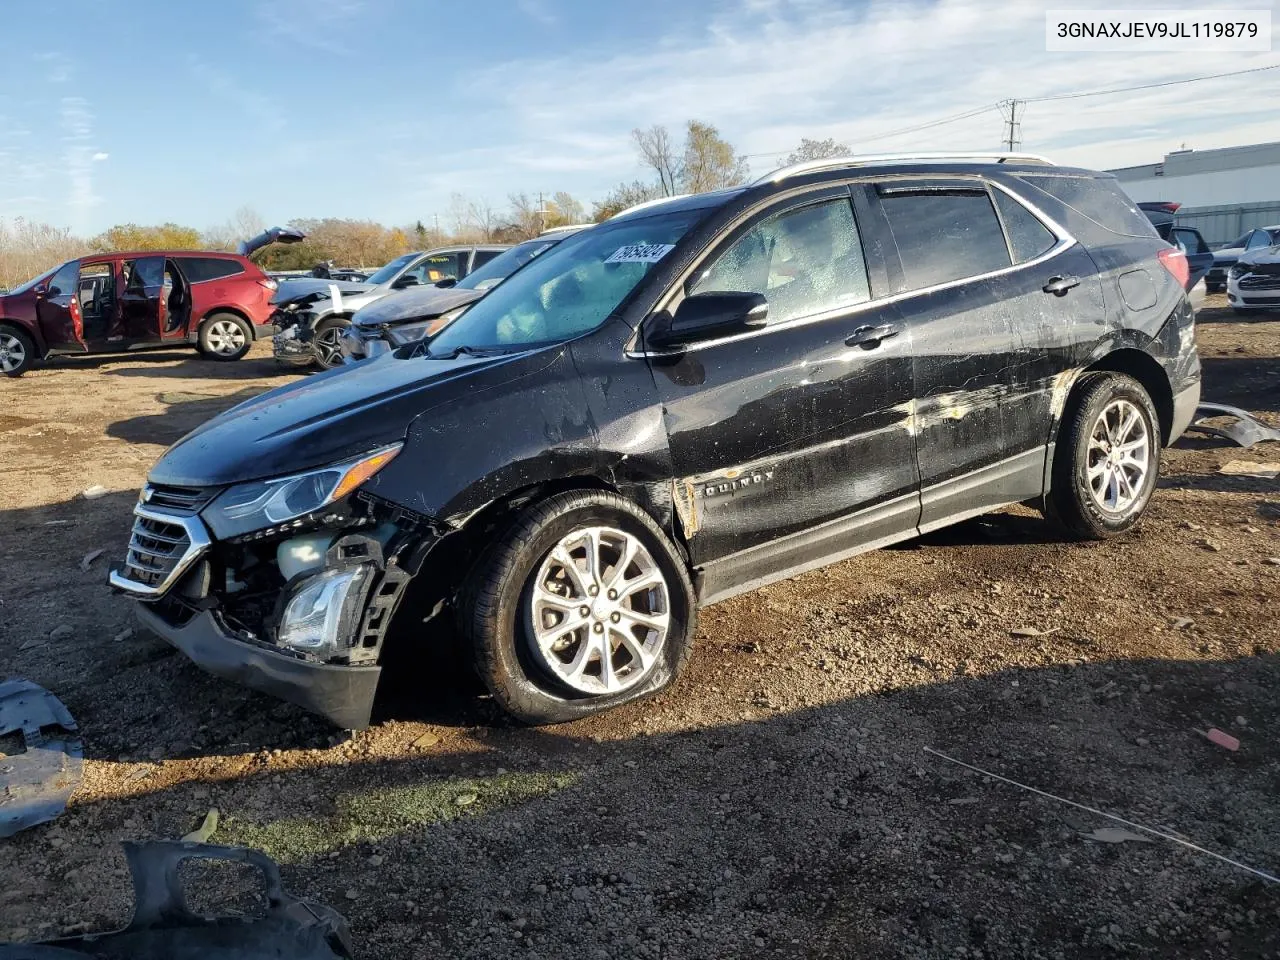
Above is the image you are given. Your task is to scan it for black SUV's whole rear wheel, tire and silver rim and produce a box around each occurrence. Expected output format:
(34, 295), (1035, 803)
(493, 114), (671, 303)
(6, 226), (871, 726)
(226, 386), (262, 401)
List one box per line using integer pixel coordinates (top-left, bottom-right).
(1048, 371), (1161, 540)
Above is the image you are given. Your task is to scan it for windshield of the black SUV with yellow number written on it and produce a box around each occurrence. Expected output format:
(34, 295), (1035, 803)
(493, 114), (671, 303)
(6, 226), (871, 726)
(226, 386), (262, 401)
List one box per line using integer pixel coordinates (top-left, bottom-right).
(428, 210), (707, 356)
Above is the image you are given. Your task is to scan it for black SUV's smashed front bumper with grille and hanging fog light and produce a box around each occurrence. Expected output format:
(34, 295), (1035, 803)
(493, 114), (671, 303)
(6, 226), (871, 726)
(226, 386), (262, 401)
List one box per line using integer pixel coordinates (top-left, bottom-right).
(110, 488), (438, 730)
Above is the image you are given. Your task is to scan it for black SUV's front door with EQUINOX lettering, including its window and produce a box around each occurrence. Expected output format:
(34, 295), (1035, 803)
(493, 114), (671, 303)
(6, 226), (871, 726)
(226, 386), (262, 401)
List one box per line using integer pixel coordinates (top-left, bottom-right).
(650, 187), (919, 600)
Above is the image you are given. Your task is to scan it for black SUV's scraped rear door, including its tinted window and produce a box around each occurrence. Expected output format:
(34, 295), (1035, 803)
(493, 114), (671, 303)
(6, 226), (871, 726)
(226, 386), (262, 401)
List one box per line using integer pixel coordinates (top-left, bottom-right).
(877, 178), (1048, 532)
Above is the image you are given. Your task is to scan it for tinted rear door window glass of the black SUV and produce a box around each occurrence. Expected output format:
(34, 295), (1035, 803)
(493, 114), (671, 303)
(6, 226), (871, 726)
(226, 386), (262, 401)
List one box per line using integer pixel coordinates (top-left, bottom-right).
(881, 188), (1011, 291)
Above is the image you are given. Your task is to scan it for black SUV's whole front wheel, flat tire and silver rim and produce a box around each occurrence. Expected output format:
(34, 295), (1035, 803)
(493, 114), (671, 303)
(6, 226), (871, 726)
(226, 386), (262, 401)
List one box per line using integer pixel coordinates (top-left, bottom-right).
(457, 490), (696, 726)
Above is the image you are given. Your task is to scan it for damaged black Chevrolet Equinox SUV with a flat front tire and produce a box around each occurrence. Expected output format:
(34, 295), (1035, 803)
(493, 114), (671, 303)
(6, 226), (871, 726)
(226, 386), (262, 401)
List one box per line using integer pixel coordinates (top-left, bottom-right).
(111, 155), (1201, 727)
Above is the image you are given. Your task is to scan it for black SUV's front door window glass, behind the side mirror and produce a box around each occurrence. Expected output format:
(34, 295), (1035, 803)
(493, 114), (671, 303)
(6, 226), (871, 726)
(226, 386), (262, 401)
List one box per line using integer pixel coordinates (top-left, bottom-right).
(689, 198), (872, 323)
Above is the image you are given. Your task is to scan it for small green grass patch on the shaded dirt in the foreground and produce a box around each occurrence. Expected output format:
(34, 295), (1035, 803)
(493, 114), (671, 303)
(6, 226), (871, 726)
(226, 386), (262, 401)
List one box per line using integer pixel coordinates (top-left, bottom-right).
(216, 773), (577, 863)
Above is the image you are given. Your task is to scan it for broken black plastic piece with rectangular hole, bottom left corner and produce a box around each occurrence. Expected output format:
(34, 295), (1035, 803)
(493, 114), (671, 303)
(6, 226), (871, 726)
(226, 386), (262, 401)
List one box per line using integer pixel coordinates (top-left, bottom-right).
(0, 841), (352, 960)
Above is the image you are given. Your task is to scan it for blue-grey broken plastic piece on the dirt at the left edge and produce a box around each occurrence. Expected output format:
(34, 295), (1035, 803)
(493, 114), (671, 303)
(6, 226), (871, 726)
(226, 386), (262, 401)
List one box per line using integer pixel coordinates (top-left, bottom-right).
(0, 680), (84, 838)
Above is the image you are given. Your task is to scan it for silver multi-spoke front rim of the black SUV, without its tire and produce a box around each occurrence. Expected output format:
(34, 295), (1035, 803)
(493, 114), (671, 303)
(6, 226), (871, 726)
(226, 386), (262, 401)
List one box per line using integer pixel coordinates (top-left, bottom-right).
(529, 526), (671, 695)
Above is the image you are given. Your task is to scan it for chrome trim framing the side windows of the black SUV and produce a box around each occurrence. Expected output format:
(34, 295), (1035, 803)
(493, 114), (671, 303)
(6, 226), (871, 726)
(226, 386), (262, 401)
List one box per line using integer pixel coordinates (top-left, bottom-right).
(625, 174), (1078, 360)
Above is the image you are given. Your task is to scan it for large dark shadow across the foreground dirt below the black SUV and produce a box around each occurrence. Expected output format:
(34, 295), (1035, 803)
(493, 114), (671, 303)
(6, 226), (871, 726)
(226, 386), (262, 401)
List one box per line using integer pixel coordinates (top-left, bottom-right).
(0, 653), (1280, 960)
